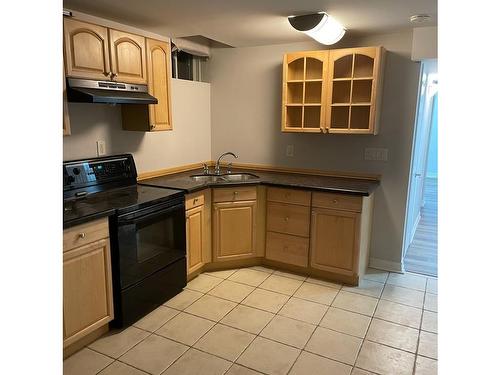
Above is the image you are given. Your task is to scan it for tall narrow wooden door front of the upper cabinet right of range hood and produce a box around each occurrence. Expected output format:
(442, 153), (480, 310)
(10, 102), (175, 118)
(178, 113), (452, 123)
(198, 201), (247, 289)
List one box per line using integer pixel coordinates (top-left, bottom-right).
(146, 39), (172, 131)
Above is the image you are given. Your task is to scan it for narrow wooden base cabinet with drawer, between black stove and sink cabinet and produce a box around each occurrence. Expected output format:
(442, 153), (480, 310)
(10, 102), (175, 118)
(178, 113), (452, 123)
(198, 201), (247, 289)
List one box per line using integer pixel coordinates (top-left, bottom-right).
(186, 189), (212, 276)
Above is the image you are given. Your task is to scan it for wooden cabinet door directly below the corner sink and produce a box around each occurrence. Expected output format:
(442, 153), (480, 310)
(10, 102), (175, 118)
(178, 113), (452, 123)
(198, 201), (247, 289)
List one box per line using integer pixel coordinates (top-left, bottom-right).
(213, 200), (257, 261)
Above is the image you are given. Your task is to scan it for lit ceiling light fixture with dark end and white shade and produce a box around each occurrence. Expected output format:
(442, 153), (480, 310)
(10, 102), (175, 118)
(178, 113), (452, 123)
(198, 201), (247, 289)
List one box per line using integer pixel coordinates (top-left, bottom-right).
(288, 12), (345, 45)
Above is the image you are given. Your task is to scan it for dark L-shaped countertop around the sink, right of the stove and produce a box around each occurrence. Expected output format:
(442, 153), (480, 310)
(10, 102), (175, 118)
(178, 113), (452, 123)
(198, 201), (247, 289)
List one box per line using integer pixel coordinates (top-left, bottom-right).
(139, 168), (380, 196)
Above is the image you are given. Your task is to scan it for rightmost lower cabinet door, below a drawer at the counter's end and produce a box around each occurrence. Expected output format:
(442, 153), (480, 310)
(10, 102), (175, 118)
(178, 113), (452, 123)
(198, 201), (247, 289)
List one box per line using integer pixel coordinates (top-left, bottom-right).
(311, 208), (360, 275)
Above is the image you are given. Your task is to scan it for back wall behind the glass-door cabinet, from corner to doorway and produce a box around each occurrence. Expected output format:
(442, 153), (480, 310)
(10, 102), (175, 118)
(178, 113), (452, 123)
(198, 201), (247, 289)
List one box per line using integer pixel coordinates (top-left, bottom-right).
(208, 32), (419, 269)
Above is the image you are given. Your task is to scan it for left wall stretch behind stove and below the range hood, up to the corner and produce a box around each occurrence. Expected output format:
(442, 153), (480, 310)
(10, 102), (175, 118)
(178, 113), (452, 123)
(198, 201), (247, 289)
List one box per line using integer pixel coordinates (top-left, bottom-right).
(63, 79), (211, 173)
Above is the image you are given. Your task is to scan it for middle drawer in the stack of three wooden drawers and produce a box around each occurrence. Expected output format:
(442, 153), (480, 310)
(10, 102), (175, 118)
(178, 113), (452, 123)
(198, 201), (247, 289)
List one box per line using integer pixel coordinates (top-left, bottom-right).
(267, 202), (310, 237)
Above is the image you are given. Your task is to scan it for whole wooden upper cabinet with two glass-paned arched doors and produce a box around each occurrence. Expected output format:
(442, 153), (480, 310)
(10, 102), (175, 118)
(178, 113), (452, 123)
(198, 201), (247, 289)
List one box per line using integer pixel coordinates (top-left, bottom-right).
(282, 47), (385, 134)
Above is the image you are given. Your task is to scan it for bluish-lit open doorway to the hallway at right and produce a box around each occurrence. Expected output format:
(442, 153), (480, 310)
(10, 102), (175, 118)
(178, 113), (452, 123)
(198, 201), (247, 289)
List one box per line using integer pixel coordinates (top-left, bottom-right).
(403, 60), (438, 277)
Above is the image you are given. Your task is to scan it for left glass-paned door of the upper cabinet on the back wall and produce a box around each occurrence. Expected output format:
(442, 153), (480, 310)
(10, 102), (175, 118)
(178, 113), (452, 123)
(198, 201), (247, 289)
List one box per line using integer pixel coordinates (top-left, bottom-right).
(281, 51), (328, 133)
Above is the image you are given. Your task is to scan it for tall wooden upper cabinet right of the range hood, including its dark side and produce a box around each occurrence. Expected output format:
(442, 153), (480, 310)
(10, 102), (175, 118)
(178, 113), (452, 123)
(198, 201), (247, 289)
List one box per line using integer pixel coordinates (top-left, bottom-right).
(122, 39), (172, 131)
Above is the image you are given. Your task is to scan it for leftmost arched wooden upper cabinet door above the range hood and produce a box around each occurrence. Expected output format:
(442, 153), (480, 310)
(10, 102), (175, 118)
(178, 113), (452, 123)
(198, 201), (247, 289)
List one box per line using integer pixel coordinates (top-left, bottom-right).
(64, 18), (110, 80)
